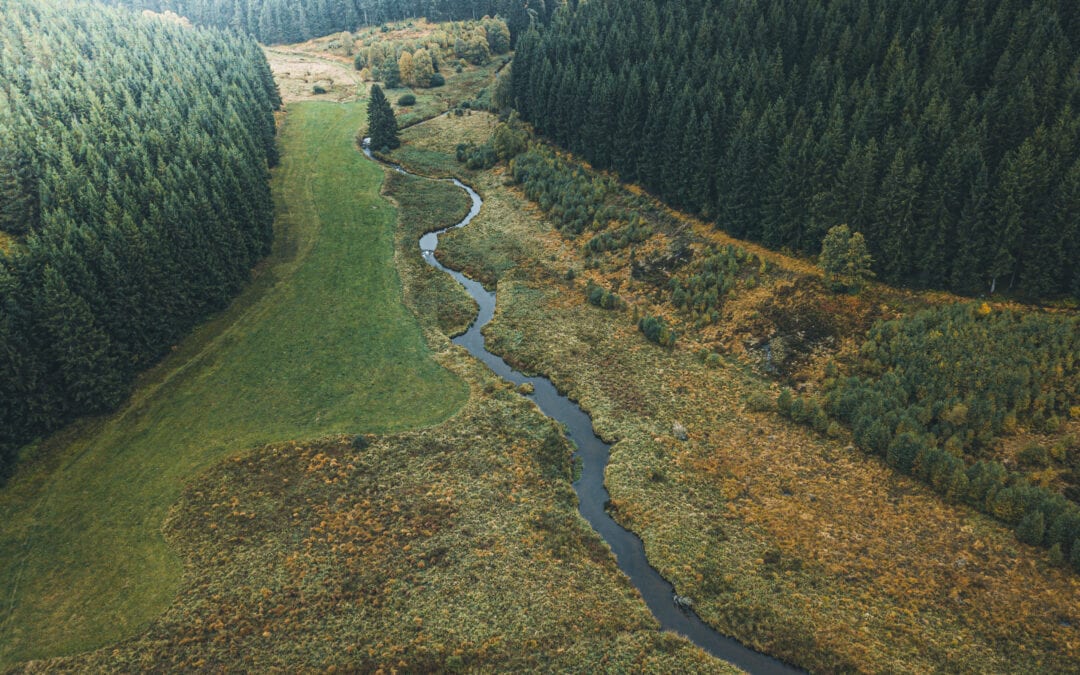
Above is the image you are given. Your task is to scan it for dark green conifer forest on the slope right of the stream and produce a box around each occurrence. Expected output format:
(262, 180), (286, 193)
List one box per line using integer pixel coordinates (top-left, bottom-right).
(513, 0), (1080, 297)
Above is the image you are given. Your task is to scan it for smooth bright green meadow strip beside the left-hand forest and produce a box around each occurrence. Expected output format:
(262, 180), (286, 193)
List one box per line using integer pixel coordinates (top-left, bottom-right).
(0, 104), (468, 665)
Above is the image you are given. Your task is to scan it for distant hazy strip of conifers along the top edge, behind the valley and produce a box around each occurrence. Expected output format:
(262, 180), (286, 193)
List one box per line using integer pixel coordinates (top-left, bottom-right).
(106, 0), (548, 44)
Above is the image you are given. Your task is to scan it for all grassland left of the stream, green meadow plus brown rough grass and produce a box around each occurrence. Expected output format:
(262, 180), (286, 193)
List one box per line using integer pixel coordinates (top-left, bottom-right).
(2, 56), (734, 673)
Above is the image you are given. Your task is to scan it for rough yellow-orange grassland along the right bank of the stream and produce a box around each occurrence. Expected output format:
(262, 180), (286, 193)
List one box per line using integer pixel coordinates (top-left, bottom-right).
(425, 113), (1080, 673)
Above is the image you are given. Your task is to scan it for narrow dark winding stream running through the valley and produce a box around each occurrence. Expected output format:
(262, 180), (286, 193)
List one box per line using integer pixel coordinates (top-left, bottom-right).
(364, 144), (801, 675)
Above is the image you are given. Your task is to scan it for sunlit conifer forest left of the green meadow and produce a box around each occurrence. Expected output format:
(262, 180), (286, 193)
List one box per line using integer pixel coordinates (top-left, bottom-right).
(0, 0), (280, 475)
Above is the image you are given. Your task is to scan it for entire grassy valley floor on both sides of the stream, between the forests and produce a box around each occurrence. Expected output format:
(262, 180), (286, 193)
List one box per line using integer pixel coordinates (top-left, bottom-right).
(6, 23), (1080, 673)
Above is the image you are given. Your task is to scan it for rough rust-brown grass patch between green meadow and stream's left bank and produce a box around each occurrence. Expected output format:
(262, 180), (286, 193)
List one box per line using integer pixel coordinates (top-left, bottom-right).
(28, 382), (733, 673)
